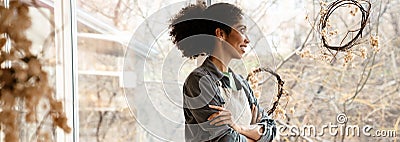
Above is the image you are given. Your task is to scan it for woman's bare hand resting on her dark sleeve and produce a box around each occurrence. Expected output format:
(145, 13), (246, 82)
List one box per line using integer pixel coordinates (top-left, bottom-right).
(207, 105), (242, 133)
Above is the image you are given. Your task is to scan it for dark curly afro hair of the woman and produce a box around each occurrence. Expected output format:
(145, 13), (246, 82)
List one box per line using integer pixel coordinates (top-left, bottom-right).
(169, 3), (243, 58)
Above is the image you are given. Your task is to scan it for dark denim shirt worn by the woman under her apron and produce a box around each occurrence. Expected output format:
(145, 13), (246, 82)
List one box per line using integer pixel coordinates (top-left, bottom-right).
(183, 57), (276, 142)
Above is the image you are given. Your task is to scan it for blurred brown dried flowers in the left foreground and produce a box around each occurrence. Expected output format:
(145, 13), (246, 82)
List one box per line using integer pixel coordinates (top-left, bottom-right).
(0, 1), (71, 142)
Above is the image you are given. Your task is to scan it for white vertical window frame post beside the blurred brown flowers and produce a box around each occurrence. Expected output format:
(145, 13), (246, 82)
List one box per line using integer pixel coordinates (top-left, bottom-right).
(54, 0), (79, 142)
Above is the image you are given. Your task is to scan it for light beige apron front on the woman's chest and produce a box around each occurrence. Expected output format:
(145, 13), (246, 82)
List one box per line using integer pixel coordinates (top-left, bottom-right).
(218, 81), (252, 126)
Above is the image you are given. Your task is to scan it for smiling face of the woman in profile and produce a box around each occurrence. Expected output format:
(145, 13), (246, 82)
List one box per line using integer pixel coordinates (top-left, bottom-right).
(225, 18), (250, 59)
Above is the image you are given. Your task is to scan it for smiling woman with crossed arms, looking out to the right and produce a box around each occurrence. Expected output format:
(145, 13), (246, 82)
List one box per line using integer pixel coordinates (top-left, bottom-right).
(170, 3), (276, 142)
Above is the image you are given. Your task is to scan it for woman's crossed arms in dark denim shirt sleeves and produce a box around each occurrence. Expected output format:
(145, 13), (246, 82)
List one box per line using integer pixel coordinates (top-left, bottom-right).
(184, 72), (276, 142)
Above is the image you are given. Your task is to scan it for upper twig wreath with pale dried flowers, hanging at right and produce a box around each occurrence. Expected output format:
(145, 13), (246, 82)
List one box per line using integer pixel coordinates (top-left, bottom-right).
(296, 0), (380, 66)
